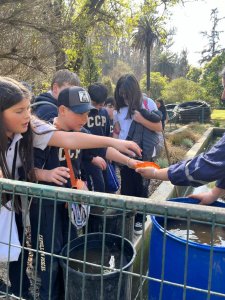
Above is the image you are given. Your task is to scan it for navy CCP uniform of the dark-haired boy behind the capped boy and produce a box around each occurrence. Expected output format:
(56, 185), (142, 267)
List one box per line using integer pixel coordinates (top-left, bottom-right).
(83, 108), (110, 192)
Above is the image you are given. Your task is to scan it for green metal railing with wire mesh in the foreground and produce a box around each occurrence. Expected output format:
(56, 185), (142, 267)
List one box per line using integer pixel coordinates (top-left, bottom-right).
(0, 179), (225, 300)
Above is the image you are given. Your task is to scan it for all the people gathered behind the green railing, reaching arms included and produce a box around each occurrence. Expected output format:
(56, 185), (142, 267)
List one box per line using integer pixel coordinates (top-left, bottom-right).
(0, 65), (225, 300)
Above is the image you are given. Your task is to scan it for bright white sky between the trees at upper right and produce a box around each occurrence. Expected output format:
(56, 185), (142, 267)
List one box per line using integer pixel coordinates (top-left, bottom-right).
(168, 0), (225, 67)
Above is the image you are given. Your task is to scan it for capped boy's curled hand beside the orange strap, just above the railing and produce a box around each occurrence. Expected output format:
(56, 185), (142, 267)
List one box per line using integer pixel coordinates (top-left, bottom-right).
(43, 167), (70, 185)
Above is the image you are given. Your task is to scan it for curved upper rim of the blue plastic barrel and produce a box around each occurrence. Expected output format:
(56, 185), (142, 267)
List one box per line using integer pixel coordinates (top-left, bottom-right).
(151, 197), (225, 252)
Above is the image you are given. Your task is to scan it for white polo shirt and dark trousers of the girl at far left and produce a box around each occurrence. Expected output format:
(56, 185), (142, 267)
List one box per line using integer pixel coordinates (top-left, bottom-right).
(6, 120), (53, 298)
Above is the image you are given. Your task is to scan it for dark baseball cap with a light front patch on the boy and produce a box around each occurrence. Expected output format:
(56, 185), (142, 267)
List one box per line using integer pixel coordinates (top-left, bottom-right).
(58, 86), (92, 114)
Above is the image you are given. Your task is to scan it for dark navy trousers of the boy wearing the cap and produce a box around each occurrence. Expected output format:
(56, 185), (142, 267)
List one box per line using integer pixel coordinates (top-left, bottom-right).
(30, 200), (77, 300)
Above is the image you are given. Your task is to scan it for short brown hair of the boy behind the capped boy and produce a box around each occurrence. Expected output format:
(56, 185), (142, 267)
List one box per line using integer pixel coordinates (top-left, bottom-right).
(51, 69), (81, 88)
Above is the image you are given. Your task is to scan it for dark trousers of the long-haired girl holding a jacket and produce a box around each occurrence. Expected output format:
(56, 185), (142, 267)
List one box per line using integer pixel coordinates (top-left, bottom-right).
(120, 166), (150, 223)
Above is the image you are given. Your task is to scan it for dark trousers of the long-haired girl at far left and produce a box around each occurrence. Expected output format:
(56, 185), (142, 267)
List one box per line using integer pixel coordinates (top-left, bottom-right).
(9, 212), (30, 296)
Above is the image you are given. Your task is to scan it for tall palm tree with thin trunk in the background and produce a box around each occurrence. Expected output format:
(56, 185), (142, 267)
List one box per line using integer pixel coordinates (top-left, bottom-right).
(132, 16), (159, 91)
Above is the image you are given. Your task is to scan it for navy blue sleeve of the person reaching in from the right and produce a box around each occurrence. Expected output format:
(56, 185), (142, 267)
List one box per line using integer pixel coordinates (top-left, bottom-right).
(168, 134), (225, 189)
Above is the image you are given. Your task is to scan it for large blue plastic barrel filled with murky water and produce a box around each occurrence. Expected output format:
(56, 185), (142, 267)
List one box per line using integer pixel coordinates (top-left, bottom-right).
(148, 198), (225, 300)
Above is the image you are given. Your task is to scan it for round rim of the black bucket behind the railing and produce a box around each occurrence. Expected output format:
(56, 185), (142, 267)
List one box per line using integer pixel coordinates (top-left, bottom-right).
(60, 232), (137, 280)
